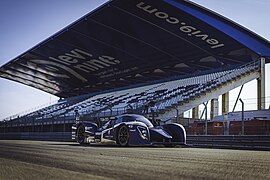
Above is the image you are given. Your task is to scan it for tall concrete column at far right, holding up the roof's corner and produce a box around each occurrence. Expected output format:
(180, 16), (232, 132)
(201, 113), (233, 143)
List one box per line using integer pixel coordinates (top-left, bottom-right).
(257, 58), (265, 110)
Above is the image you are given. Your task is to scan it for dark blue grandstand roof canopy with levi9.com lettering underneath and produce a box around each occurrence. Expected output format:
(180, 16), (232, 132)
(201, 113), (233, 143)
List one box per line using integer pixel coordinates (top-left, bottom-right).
(0, 0), (270, 97)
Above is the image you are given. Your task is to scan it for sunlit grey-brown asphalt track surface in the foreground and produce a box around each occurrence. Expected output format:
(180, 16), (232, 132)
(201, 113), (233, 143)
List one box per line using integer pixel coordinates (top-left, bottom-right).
(0, 140), (270, 180)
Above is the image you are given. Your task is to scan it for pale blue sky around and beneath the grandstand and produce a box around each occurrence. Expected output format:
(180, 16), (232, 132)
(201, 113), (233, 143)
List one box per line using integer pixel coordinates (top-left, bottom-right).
(0, 0), (270, 119)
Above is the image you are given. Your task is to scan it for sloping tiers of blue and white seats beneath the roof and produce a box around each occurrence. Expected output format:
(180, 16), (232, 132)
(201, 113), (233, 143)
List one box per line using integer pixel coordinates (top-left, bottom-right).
(0, 59), (260, 135)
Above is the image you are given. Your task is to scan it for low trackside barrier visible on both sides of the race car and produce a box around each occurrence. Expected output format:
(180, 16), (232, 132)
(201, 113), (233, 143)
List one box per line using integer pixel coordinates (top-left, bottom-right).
(0, 132), (270, 150)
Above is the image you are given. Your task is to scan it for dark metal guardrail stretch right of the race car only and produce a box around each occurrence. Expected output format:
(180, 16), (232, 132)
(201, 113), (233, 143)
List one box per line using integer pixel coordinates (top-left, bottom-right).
(187, 135), (270, 150)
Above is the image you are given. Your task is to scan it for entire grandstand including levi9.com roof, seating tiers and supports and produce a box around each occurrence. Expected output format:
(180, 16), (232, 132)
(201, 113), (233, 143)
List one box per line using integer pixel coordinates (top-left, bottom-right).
(0, 0), (270, 138)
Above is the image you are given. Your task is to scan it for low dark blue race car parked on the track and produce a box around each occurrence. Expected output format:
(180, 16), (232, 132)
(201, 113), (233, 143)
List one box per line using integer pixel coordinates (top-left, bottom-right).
(72, 114), (186, 147)
